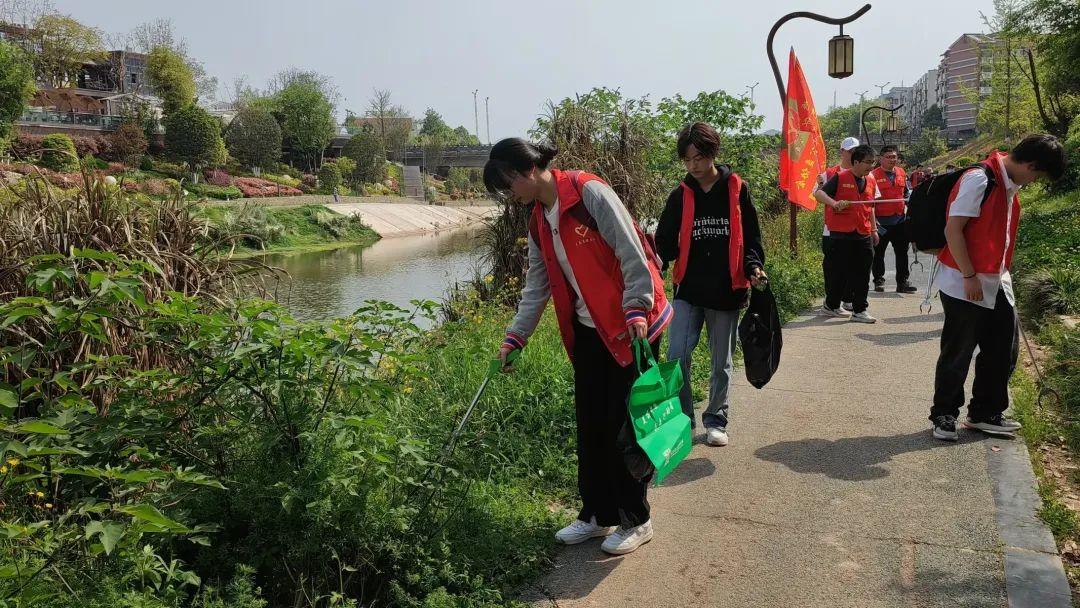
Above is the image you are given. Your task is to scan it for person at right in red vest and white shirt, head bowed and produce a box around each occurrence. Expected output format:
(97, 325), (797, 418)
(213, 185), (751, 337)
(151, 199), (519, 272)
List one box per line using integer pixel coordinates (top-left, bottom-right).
(913, 135), (1065, 442)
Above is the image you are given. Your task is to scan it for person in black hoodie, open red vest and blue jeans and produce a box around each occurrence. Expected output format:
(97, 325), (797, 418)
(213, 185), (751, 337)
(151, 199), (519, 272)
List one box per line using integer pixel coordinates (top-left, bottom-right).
(656, 122), (768, 446)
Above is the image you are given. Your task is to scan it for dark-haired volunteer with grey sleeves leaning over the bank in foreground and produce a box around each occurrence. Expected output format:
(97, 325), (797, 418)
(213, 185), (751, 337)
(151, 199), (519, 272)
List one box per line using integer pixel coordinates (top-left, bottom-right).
(484, 137), (674, 555)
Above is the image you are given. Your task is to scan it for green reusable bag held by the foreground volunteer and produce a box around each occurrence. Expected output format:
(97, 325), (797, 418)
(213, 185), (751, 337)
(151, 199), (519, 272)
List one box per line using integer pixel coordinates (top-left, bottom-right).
(626, 340), (692, 484)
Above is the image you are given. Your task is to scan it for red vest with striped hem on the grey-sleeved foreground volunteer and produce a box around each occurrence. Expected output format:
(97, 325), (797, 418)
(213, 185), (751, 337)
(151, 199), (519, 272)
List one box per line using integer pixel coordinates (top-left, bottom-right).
(530, 170), (674, 366)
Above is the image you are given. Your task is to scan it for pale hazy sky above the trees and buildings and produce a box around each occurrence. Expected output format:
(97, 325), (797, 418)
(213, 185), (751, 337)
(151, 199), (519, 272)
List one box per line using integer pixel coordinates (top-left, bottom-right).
(55, 0), (993, 140)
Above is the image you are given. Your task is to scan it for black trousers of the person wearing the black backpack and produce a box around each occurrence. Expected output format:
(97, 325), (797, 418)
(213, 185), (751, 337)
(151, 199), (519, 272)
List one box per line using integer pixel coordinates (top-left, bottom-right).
(930, 291), (1020, 421)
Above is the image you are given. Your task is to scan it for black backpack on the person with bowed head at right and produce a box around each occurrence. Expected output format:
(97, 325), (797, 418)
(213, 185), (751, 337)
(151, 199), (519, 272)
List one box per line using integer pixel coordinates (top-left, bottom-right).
(905, 163), (995, 253)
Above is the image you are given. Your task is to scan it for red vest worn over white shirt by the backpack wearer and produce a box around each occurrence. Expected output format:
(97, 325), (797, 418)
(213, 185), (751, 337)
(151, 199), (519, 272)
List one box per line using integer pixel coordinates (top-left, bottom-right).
(937, 152), (1020, 274)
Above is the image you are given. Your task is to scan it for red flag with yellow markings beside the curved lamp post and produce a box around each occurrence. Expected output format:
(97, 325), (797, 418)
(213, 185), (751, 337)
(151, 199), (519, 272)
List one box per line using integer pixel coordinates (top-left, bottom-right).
(780, 49), (825, 211)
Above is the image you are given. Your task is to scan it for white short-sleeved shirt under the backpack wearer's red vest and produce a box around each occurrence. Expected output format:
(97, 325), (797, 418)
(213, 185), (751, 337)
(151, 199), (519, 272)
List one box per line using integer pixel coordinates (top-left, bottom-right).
(937, 159), (1020, 309)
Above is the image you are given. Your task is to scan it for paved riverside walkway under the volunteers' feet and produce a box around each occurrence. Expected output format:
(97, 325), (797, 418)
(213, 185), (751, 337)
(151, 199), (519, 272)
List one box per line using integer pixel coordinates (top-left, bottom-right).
(525, 255), (1070, 608)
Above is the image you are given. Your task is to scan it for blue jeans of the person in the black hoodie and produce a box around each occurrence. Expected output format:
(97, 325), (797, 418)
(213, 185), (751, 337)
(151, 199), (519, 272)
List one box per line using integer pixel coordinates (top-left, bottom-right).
(667, 299), (741, 429)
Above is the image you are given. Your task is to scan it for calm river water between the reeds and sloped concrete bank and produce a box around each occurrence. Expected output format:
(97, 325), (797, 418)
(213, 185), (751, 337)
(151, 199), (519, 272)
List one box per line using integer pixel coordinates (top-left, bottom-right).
(261, 228), (482, 320)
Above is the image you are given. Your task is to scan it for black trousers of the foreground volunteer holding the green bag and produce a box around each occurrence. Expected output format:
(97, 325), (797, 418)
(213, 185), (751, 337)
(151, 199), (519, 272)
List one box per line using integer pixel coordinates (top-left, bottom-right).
(573, 321), (660, 526)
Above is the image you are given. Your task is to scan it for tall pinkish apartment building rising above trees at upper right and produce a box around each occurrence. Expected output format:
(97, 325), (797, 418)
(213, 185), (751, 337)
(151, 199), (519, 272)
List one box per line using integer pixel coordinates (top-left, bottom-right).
(937, 33), (999, 139)
